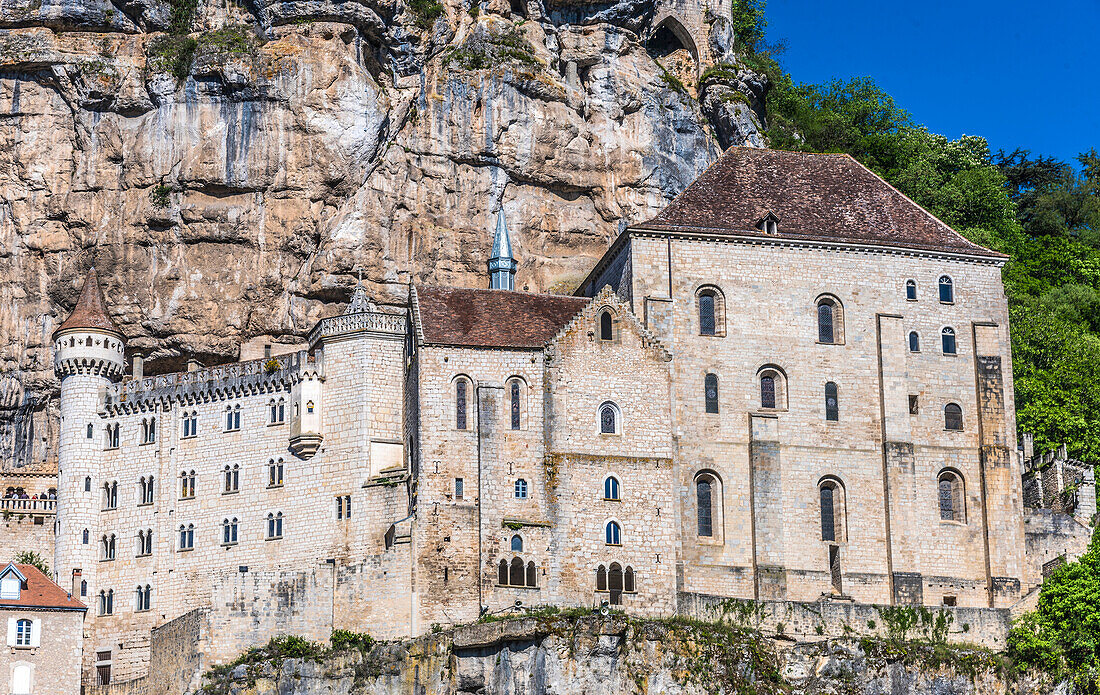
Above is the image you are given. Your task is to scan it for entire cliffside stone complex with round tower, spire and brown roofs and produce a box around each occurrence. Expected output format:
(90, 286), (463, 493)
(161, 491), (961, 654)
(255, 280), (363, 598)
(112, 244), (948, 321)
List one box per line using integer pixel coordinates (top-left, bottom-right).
(27, 147), (1073, 684)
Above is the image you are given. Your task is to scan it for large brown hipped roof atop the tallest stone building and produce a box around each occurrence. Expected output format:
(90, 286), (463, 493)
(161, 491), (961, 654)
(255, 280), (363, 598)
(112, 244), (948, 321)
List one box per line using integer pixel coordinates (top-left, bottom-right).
(635, 147), (1007, 258)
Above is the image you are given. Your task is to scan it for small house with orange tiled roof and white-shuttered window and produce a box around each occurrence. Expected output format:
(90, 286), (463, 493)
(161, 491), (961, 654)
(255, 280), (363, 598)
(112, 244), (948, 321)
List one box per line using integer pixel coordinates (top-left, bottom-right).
(0, 563), (85, 695)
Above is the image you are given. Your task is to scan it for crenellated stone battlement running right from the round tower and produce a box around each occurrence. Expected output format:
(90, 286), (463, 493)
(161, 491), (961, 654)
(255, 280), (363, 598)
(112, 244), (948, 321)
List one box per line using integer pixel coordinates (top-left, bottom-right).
(103, 351), (325, 415)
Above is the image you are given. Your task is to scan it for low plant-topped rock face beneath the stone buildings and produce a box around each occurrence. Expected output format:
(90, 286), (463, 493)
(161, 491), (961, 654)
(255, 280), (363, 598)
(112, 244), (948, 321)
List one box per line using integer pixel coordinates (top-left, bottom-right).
(193, 618), (1066, 695)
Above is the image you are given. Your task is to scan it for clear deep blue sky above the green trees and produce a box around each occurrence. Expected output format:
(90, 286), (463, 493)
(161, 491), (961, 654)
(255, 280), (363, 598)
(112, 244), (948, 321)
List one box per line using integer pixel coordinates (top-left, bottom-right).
(766, 0), (1100, 165)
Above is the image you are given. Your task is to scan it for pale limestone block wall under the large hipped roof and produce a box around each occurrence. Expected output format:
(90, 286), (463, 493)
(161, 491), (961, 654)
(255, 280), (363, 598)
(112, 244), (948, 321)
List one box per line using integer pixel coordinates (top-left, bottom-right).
(629, 235), (1022, 606)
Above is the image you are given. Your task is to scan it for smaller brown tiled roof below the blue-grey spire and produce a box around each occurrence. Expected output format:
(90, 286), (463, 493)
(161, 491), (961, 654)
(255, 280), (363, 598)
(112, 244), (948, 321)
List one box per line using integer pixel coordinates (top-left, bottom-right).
(415, 287), (589, 348)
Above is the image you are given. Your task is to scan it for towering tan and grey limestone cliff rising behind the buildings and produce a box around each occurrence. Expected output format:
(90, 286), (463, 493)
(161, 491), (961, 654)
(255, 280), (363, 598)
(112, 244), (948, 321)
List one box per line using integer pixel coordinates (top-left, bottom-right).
(0, 0), (767, 466)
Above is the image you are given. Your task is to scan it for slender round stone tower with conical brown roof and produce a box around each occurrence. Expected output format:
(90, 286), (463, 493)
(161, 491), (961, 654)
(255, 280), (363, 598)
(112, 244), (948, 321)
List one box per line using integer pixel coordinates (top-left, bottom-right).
(54, 268), (125, 616)
